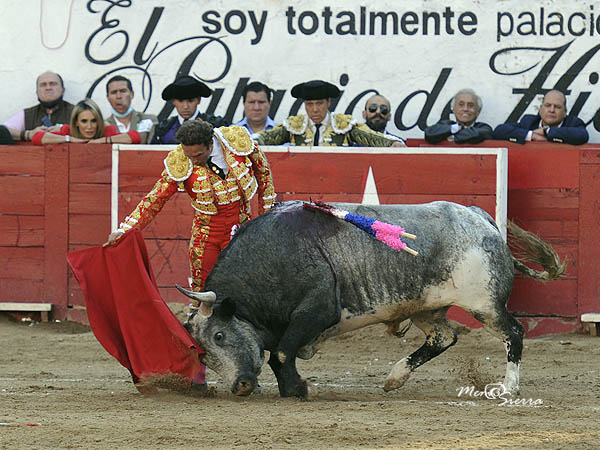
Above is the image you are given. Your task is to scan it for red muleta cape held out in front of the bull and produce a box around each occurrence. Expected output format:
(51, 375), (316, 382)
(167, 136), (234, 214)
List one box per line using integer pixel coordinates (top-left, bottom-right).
(67, 230), (204, 383)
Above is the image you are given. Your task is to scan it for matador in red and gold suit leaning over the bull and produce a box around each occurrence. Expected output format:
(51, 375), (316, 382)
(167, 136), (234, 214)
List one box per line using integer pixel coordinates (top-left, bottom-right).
(105, 120), (275, 291)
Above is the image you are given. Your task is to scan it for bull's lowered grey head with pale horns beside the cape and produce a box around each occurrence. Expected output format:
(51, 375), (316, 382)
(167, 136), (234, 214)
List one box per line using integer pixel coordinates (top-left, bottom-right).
(177, 286), (264, 395)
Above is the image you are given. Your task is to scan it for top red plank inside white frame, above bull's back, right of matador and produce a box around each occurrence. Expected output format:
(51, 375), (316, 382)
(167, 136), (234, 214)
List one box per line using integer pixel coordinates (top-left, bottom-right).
(266, 152), (496, 195)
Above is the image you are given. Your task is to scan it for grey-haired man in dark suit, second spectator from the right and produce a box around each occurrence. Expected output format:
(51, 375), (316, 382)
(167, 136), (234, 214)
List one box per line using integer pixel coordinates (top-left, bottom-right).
(425, 89), (492, 144)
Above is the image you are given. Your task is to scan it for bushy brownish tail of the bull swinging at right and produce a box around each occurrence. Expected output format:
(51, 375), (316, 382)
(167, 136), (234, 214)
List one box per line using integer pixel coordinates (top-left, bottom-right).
(508, 220), (567, 282)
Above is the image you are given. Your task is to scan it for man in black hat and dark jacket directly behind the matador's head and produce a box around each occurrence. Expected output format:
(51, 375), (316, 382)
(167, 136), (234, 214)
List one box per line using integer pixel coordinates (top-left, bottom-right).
(152, 75), (229, 144)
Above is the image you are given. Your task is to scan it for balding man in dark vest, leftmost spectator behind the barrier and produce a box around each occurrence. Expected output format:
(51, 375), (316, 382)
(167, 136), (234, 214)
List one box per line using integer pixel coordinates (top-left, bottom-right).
(4, 72), (73, 141)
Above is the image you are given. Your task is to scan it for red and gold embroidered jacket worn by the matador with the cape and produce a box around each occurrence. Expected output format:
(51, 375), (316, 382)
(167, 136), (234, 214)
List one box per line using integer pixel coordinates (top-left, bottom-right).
(119, 126), (275, 231)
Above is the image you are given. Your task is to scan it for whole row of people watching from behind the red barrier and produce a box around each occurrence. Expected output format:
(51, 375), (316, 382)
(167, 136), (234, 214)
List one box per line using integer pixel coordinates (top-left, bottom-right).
(0, 72), (589, 147)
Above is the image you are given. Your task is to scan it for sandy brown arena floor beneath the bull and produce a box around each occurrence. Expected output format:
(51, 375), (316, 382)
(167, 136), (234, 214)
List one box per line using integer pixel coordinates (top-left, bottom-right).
(0, 310), (600, 450)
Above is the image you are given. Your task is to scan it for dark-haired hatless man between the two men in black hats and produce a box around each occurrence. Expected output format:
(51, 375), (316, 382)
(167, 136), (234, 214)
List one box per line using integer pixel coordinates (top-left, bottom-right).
(236, 81), (277, 134)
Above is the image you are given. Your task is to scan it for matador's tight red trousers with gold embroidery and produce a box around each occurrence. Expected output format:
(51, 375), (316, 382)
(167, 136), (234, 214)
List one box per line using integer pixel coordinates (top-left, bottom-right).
(189, 201), (240, 384)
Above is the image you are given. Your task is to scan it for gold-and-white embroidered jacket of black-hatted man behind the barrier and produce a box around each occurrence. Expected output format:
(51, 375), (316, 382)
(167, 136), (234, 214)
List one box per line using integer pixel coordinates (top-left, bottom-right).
(257, 114), (399, 147)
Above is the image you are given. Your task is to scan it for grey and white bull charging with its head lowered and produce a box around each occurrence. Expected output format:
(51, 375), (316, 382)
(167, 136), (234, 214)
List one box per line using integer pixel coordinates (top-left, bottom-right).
(178, 202), (564, 398)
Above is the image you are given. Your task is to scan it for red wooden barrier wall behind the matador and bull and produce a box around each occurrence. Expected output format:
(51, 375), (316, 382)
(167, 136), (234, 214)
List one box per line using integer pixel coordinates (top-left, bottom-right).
(0, 140), (600, 336)
